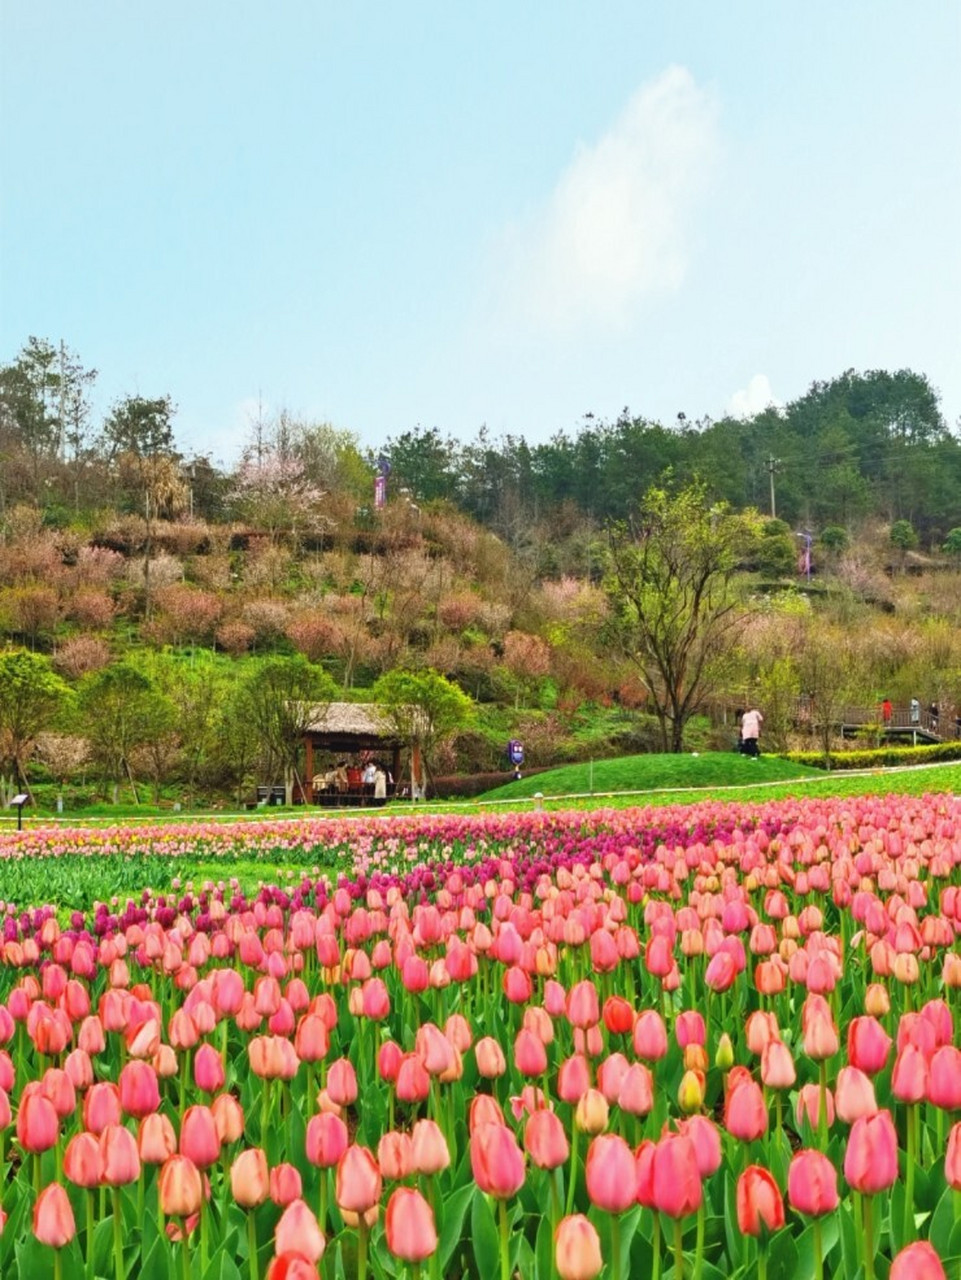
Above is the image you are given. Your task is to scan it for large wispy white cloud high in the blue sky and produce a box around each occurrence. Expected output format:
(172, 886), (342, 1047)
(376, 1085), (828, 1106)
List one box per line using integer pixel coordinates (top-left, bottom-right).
(494, 67), (719, 329)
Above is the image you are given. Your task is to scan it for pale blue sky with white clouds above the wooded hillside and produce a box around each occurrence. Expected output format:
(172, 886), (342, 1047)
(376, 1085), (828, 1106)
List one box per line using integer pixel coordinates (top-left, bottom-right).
(0, 0), (961, 465)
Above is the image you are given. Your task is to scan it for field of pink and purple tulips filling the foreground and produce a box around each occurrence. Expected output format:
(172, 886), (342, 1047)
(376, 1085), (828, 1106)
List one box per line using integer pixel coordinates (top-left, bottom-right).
(0, 795), (961, 1280)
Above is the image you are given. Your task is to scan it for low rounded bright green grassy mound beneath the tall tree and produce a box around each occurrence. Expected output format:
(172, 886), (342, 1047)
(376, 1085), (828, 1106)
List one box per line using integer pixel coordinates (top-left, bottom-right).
(481, 751), (823, 800)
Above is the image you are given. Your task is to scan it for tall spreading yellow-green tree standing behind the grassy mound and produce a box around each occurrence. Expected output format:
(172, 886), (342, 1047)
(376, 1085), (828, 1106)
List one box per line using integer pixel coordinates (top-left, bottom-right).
(604, 480), (751, 751)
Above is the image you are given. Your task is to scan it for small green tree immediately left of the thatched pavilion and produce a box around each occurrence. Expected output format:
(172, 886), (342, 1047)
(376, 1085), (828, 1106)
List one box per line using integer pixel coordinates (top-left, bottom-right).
(239, 654), (337, 804)
